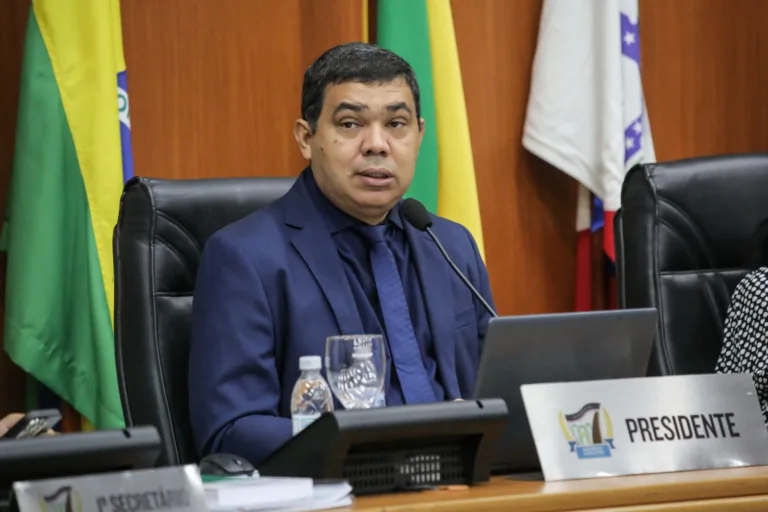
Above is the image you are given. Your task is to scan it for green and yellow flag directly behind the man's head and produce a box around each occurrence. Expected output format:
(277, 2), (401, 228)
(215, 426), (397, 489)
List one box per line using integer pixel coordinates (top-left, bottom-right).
(376, 0), (485, 257)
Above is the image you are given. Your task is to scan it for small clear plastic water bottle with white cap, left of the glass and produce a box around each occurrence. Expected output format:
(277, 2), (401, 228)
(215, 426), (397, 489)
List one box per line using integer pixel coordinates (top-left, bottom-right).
(291, 356), (333, 435)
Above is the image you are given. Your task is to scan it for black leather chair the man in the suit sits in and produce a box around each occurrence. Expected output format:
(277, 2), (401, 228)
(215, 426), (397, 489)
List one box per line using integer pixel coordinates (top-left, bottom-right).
(113, 178), (295, 465)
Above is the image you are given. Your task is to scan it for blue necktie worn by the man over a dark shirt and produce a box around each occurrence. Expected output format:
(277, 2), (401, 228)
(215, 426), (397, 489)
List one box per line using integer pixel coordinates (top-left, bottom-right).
(361, 225), (435, 404)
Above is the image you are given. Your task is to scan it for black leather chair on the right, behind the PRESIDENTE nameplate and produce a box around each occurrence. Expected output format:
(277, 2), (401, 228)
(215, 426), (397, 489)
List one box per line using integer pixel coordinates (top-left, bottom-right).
(614, 154), (768, 375)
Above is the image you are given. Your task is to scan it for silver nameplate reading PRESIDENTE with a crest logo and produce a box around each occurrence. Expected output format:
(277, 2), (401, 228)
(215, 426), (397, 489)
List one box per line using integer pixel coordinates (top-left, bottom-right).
(520, 374), (768, 481)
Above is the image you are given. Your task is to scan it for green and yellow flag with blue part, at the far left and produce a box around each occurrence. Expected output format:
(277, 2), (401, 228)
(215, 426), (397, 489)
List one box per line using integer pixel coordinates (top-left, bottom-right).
(3, 0), (133, 428)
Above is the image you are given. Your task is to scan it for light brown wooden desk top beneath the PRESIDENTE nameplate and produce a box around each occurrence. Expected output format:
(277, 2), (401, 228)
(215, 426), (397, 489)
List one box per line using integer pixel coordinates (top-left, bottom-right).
(351, 466), (768, 512)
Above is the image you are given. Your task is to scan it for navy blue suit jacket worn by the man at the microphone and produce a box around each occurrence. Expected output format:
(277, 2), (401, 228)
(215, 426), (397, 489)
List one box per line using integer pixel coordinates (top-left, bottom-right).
(189, 174), (493, 465)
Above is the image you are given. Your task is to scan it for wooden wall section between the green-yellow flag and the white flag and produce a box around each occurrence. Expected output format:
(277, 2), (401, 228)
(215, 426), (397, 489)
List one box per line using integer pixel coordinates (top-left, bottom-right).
(451, 0), (576, 314)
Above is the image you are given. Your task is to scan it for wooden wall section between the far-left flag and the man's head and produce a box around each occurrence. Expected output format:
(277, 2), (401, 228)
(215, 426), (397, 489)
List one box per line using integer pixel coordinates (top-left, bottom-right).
(122, 0), (363, 178)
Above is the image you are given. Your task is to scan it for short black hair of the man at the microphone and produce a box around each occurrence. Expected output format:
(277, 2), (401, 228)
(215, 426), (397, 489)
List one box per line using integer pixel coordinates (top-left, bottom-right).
(301, 42), (421, 132)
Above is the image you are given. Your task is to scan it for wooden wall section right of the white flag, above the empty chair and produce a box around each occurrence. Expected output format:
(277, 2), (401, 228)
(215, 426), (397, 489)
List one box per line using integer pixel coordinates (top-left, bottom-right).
(640, 0), (768, 160)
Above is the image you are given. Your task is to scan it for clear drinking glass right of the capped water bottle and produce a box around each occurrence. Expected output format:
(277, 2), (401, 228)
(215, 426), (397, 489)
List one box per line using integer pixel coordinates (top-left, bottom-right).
(325, 334), (386, 409)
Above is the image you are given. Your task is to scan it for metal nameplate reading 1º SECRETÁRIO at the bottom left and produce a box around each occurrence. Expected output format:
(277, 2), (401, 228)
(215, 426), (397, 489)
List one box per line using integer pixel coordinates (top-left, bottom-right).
(13, 465), (208, 512)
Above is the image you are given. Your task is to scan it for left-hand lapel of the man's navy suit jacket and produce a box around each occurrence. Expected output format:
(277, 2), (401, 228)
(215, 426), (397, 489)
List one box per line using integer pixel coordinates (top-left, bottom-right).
(285, 174), (363, 334)
